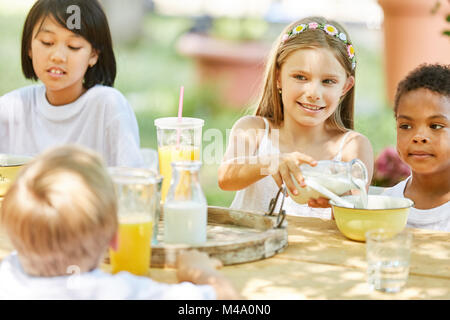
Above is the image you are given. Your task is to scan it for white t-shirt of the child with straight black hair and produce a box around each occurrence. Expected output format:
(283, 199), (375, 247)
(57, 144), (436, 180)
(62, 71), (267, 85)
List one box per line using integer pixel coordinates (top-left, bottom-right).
(0, 85), (142, 167)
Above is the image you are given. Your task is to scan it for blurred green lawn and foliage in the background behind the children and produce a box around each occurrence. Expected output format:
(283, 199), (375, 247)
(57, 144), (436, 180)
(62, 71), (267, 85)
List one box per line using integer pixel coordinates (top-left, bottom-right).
(0, 12), (395, 206)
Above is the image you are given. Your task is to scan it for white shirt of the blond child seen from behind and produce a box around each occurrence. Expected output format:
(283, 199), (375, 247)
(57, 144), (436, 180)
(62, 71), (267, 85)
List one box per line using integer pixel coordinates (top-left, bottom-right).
(0, 252), (217, 300)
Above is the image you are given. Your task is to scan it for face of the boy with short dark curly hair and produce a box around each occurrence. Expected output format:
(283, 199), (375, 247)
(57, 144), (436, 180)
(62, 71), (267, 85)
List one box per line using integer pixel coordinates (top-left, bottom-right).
(396, 88), (450, 174)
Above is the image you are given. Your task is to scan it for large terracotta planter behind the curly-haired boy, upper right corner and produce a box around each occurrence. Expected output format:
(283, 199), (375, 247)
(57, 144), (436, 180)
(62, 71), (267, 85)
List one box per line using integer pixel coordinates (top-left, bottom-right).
(378, 0), (450, 104)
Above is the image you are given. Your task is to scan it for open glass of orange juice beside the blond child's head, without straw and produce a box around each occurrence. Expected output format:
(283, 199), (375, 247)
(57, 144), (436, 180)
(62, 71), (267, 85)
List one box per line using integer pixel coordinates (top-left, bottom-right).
(109, 167), (161, 276)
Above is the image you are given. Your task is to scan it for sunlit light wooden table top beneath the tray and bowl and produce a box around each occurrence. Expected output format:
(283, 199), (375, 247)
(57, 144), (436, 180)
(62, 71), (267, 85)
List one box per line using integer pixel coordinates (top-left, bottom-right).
(0, 216), (450, 300)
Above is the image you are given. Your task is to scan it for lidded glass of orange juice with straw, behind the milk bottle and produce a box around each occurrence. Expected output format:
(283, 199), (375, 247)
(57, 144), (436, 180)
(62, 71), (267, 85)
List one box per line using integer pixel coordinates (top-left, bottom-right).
(155, 117), (204, 202)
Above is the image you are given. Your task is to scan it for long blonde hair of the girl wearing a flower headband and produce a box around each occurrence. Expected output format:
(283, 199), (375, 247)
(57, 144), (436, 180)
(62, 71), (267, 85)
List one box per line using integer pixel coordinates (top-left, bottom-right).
(255, 17), (355, 131)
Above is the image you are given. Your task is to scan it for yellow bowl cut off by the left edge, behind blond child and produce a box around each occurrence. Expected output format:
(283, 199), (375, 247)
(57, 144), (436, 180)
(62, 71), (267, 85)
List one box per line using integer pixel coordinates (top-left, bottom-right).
(0, 153), (33, 197)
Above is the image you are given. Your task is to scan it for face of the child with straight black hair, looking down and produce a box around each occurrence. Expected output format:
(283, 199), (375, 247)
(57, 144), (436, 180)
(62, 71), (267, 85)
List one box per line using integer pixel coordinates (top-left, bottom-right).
(29, 16), (98, 105)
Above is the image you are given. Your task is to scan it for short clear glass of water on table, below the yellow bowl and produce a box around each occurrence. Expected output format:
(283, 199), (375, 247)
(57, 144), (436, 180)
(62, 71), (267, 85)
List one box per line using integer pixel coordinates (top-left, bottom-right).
(366, 229), (412, 293)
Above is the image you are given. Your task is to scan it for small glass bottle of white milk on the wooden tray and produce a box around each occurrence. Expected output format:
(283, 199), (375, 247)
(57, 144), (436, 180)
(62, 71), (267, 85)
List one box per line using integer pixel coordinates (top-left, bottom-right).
(164, 161), (208, 245)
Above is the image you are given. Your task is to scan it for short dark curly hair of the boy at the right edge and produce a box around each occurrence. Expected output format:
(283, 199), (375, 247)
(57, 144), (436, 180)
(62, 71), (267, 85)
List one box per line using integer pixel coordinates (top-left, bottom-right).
(394, 63), (450, 114)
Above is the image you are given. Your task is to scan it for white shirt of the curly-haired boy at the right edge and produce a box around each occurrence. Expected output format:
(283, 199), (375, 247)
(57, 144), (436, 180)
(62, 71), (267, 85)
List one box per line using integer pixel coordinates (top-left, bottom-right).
(383, 177), (450, 232)
